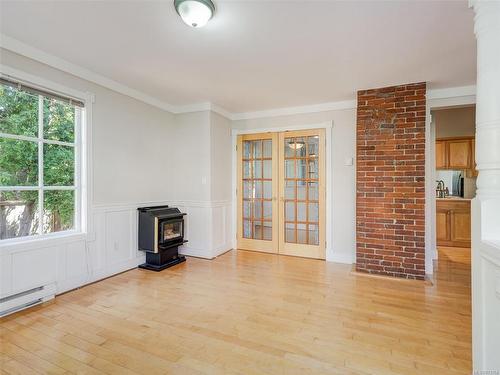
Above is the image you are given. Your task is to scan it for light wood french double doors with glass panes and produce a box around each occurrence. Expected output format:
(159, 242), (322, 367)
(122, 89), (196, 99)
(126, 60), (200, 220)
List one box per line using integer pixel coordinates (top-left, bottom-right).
(237, 129), (325, 259)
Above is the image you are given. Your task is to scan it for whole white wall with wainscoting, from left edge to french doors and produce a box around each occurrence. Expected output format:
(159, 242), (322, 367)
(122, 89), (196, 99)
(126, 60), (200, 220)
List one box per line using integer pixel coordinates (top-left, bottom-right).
(0, 49), (231, 304)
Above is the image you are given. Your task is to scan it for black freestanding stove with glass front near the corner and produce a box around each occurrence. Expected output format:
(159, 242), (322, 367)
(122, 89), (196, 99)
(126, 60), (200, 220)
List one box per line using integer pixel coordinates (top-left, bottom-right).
(138, 206), (187, 271)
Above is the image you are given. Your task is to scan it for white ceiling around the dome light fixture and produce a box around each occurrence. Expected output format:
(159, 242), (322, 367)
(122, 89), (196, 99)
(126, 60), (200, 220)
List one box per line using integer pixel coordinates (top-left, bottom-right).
(0, 0), (476, 112)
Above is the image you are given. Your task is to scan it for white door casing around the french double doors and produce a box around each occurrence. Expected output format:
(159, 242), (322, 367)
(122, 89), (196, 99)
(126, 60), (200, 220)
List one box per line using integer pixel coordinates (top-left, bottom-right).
(231, 121), (335, 262)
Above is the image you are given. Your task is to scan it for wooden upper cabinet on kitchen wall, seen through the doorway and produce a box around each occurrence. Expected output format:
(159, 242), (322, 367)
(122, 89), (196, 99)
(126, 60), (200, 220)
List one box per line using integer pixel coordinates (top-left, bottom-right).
(436, 137), (476, 171)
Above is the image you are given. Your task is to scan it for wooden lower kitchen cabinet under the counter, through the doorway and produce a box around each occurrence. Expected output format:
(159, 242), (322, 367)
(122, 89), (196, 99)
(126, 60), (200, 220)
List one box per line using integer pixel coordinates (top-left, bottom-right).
(436, 198), (471, 247)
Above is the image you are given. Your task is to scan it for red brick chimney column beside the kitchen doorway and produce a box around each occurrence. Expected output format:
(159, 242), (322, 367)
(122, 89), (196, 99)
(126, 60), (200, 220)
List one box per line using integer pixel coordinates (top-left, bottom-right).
(356, 83), (426, 279)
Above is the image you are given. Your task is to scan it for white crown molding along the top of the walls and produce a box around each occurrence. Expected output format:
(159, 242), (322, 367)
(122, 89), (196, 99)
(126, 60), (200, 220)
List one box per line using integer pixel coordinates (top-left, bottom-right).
(0, 33), (476, 121)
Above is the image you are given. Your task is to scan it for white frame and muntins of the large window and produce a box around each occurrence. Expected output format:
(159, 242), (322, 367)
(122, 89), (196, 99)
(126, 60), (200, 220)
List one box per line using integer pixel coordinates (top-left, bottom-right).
(0, 65), (94, 248)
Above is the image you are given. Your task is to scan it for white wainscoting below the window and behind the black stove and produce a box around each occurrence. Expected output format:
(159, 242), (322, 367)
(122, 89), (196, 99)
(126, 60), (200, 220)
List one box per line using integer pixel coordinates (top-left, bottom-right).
(0, 201), (232, 308)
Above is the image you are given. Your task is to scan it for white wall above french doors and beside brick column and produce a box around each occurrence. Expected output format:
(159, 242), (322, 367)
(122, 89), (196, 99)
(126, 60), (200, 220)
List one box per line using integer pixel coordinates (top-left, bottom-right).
(233, 109), (356, 263)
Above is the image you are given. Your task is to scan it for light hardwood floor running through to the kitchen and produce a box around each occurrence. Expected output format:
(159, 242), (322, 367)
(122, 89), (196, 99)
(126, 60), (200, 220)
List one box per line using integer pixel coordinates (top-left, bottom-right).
(0, 249), (471, 375)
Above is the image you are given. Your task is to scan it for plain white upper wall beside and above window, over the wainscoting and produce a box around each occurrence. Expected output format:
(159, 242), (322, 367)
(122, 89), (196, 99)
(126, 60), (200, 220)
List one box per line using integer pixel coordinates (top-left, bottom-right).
(1, 49), (179, 205)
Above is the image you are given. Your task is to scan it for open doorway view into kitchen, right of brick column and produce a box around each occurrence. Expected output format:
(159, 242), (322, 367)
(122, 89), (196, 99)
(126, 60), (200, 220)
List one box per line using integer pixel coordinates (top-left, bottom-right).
(431, 105), (477, 271)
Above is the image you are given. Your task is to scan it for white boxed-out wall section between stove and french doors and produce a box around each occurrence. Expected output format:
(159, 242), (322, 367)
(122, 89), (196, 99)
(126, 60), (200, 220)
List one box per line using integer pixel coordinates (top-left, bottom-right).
(166, 111), (232, 259)
